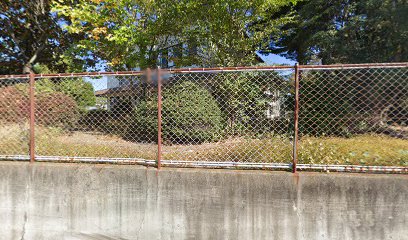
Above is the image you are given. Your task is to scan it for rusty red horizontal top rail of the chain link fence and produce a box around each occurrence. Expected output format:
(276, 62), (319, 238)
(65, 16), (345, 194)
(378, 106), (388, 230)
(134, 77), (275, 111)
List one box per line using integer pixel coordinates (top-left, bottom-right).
(0, 62), (408, 80)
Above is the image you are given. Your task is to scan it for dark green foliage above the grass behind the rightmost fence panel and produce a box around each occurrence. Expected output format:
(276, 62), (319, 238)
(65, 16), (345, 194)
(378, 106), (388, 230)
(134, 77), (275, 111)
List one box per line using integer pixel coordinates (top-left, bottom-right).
(299, 69), (408, 137)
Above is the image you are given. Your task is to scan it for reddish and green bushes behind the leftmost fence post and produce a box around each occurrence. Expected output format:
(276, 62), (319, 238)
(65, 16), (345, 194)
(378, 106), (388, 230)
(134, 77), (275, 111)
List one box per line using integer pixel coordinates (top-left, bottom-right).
(0, 78), (95, 129)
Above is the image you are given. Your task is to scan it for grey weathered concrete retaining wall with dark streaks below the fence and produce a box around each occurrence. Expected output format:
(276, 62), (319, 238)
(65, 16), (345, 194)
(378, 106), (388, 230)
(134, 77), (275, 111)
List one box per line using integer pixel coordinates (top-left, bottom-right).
(0, 162), (408, 240)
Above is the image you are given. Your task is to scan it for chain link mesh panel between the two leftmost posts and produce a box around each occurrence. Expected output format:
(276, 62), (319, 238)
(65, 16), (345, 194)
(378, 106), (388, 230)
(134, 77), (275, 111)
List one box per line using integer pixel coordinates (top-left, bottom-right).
(35, 75), (157, 159)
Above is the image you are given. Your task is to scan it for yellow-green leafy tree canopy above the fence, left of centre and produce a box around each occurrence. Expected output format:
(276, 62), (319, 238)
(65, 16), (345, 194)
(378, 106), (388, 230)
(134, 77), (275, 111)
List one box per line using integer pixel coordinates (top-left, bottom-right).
(54, 0), (188, 70)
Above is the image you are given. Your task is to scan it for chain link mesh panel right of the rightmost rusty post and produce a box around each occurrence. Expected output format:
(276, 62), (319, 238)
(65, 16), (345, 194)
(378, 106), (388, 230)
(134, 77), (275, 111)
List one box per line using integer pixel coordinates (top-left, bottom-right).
(299, 68), (408, 166)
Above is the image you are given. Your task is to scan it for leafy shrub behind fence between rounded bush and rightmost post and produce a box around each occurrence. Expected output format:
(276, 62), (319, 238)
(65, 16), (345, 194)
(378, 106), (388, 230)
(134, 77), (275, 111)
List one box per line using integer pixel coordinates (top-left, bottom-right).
(211, 72), (291, 135)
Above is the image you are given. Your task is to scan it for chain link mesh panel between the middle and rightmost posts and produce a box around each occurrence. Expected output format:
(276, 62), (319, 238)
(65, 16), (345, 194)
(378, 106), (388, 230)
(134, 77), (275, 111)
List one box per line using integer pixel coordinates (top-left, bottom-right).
(163, 70), (294, 163)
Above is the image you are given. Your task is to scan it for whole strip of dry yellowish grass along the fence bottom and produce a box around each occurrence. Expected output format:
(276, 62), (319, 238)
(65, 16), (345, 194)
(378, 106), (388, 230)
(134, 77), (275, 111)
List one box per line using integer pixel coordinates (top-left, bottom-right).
(0, 124), (408, 166)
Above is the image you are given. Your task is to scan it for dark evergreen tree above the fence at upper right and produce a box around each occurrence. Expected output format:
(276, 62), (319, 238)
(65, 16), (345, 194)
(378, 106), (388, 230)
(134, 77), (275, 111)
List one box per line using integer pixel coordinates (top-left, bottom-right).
(267, 0), (408, 64)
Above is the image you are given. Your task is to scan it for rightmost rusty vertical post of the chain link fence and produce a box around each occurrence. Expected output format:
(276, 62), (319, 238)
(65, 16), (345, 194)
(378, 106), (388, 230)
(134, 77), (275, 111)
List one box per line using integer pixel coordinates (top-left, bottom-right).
(292, 63), (299, 173)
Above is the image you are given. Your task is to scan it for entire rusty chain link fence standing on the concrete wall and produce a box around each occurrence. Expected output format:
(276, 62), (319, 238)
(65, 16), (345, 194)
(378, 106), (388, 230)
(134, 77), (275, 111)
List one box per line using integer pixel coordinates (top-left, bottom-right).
(0, 63), (408, 172)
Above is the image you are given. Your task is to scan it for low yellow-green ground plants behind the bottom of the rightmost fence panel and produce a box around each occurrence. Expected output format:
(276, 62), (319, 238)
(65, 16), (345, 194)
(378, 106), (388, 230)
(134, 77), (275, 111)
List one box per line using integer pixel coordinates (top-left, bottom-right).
(299, 134), (408, 166)
